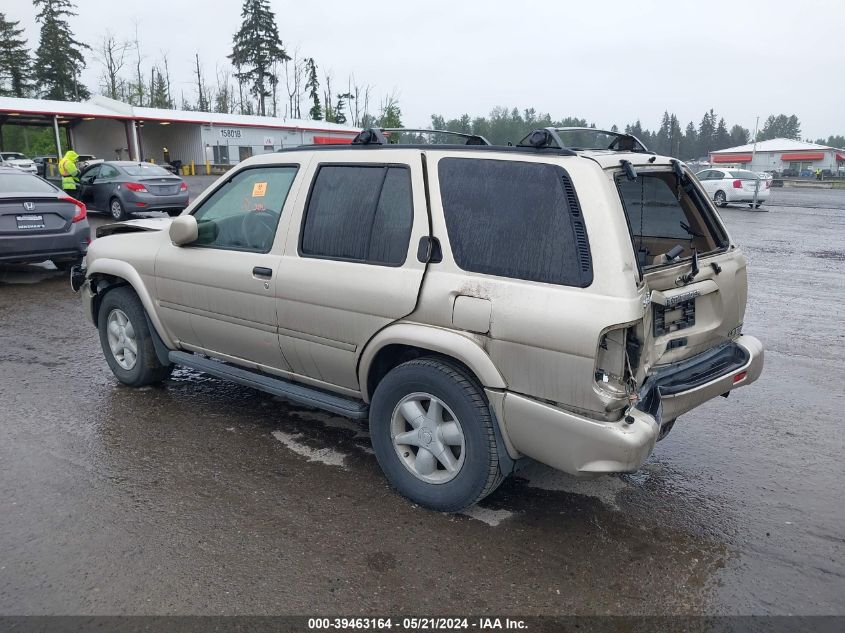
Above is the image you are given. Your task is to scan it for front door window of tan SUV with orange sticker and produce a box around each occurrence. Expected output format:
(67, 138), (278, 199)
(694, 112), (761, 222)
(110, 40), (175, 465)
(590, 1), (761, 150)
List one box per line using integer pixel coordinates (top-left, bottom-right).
(194, 166), (298, 253)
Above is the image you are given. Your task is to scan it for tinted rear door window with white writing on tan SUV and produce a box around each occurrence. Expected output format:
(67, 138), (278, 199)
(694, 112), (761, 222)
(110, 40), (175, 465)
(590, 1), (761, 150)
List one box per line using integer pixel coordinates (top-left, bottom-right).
(300, 165), (414, 266)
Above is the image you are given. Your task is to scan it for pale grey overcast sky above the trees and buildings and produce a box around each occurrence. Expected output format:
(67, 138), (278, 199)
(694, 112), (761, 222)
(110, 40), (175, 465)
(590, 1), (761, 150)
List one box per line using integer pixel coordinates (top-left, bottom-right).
(2, 0), (845, 139)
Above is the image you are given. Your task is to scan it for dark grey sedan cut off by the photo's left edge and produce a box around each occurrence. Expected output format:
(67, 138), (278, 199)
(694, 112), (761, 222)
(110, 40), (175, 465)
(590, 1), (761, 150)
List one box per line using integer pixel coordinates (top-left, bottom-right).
(0, 167), (91, 270)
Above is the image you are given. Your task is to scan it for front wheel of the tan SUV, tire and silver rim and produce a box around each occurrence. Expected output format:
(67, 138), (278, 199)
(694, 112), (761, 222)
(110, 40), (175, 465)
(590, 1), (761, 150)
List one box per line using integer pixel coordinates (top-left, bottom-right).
(97, 286), (173, 387)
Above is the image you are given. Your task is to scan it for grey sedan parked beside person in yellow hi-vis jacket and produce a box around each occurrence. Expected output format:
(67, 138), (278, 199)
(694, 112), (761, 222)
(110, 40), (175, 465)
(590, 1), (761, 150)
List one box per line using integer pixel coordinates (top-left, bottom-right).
(79, 161), (188, 220)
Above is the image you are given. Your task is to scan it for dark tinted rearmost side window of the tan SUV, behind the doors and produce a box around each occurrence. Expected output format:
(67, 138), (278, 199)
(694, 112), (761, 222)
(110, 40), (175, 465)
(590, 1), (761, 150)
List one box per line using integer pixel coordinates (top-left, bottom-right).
(438, 158), (593, 288)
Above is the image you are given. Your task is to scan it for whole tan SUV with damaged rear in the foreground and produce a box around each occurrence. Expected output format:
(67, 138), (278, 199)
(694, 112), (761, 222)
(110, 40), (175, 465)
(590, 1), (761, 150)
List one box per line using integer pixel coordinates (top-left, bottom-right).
(71, 129), (763, 511)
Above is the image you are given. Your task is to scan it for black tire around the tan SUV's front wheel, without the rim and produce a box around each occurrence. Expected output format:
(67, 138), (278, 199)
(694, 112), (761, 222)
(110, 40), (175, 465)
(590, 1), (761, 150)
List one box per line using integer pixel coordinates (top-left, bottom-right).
(97, 286), (173, 387)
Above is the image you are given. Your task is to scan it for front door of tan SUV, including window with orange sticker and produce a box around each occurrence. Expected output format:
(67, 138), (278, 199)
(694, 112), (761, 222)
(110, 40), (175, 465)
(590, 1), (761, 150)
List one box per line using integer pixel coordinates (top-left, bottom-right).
(155, 163), (301, 372)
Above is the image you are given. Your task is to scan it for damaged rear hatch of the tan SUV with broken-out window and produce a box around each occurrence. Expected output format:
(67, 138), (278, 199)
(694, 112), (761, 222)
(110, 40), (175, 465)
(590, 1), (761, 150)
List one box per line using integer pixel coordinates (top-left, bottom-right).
(615, 166), (744, 381)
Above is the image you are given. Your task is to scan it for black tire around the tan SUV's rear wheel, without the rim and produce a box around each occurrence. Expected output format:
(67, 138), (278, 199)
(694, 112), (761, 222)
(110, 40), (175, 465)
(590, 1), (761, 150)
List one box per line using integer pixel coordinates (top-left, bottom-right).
(370, 358), (504, 512)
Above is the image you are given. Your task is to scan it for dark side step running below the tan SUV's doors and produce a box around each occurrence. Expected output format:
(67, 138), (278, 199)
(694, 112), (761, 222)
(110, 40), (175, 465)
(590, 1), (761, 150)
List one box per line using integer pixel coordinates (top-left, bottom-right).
(168, 352), (370, 420)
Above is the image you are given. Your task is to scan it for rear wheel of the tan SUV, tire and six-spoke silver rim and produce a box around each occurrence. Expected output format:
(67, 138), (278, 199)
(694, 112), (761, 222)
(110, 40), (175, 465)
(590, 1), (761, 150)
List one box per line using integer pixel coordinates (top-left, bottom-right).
(370, 358), (503, 512)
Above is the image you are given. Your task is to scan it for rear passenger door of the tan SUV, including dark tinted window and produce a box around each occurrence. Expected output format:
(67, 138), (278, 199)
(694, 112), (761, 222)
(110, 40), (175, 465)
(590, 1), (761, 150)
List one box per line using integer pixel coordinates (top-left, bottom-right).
(276, 149), (429, 393)
